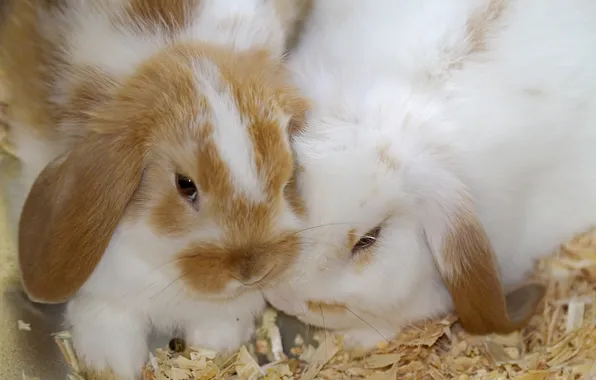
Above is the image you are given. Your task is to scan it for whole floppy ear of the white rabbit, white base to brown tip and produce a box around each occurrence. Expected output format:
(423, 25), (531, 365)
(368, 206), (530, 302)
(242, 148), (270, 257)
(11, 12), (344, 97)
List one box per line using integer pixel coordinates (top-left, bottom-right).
(425, 190), (546, 335)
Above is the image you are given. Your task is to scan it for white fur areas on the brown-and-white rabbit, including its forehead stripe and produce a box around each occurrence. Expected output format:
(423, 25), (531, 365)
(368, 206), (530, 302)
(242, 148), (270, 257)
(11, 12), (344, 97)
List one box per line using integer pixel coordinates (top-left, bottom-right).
(5, 0), (298, 380)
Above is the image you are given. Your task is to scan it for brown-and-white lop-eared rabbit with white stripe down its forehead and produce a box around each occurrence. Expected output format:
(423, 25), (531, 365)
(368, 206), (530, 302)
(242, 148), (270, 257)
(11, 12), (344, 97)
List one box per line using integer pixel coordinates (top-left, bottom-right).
(0, 0), (308, 379)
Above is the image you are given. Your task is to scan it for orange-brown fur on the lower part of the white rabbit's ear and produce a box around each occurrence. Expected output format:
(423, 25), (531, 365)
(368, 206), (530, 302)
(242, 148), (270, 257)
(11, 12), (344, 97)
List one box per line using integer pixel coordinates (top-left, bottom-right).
(443, 211), (542, 334)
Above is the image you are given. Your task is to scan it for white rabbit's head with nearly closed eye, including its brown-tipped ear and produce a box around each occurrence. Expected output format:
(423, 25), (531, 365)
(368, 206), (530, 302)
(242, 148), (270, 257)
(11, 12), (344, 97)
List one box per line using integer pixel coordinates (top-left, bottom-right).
(266, 83), (544, 334)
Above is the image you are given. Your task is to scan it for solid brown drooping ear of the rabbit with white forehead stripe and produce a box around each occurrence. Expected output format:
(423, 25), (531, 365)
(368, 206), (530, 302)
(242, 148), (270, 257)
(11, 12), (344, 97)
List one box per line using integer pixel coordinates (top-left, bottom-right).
(19, 133), (143, 303)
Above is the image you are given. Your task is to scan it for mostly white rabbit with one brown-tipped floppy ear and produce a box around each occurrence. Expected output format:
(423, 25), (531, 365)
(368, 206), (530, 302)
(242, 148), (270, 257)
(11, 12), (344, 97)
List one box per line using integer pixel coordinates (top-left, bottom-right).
(264, 0), (596, 349)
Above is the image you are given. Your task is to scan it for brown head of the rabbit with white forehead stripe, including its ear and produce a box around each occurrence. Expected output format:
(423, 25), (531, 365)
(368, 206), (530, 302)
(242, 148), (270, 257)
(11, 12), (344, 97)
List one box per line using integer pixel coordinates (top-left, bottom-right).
(19, 44), (306, 303)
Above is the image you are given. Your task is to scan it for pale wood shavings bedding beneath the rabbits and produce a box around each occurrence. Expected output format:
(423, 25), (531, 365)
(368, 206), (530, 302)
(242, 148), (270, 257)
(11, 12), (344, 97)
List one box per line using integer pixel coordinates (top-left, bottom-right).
(50, 229), (596, 380)
